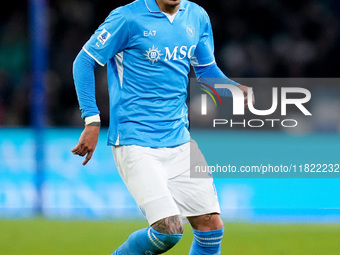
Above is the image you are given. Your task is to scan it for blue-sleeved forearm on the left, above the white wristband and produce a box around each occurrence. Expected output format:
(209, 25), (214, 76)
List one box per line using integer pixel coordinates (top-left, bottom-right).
(73, 50), (100, 118)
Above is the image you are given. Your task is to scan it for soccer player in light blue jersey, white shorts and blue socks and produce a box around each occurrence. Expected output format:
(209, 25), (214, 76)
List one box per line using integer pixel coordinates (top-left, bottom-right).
(72, 0), (252, 255)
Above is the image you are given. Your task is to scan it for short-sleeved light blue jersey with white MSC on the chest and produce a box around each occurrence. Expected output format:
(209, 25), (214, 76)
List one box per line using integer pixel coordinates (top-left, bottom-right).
(83, 0), (215, 147)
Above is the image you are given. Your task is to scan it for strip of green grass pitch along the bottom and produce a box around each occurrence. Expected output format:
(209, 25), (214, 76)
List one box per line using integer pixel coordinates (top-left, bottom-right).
(0, 219), (340, 255)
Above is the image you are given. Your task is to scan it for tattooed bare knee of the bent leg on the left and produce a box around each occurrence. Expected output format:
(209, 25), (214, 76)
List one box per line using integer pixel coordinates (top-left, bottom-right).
(151, 215), (183, 234)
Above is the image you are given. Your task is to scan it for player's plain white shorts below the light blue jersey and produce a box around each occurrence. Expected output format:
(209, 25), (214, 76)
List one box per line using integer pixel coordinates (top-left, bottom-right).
(112, 140), (220, 225)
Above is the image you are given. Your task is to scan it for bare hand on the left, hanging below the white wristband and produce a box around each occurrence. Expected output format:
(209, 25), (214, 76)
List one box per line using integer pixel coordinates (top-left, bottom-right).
(71, 126), (100, 166)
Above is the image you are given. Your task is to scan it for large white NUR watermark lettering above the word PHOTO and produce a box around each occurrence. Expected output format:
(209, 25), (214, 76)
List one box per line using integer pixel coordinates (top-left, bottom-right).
(201, 84), (312, 116)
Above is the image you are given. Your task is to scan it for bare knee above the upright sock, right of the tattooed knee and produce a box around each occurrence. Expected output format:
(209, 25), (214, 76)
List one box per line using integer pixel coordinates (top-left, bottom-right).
(188, 213), (224, 231)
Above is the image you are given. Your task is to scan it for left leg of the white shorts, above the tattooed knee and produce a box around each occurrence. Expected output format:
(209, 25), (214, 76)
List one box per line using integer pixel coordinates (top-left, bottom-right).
(113, 146), (180, 225)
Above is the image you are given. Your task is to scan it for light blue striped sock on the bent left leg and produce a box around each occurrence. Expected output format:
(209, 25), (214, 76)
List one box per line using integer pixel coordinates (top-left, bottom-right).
(112, 227), (182, 255)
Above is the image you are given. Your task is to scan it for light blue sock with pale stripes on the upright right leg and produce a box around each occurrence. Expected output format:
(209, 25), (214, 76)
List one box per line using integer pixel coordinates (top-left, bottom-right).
(189, 228), (224, 255)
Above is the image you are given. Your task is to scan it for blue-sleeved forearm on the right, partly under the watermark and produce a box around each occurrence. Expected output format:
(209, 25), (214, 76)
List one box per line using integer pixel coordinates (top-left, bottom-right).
(194, 63), (240, 96)
